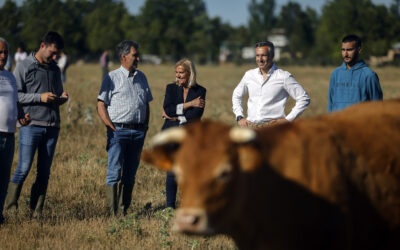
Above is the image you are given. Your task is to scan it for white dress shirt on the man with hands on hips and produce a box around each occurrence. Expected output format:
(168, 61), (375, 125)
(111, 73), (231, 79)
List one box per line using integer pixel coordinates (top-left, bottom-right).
(232, 64), (310, 123)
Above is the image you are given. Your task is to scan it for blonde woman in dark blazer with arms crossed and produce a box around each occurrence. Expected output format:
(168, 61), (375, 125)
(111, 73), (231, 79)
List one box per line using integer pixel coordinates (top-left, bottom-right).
(162, 59), (206, 209)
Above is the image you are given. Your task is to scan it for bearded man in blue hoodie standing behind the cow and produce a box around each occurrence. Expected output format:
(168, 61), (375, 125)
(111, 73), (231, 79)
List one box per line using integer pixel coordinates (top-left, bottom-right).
(328, 35), (383, 113)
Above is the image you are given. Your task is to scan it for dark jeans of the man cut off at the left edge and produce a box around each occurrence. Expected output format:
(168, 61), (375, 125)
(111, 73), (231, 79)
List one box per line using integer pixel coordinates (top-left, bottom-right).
(0, 133), (15, 224)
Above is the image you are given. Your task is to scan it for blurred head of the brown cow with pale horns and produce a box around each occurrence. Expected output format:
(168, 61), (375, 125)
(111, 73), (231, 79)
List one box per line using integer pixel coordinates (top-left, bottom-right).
(142, 121), (262, 234)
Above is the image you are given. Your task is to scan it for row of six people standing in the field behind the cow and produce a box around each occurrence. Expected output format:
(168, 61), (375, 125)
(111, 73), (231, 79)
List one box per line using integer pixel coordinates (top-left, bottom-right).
(0, 31), (383, 224)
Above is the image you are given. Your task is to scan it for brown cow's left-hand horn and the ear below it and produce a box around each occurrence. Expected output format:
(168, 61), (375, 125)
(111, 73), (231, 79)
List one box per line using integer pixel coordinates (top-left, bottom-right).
(142, 128), (186, 171)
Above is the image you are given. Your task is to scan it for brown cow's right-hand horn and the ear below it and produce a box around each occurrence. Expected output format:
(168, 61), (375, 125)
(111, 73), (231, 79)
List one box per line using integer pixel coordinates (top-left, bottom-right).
(229, 127), (262, 172)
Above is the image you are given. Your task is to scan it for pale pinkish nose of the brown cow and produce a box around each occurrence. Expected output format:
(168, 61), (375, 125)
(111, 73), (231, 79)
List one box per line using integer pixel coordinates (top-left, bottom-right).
(172, 208), (208, 234)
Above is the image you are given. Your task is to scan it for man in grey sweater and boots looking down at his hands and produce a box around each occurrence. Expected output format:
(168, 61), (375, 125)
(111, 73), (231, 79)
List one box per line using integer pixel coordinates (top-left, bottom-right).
(6, 31), (68, 218)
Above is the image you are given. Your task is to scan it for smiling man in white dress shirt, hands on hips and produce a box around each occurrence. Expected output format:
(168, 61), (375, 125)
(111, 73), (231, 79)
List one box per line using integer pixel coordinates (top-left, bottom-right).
(232, 41), (310, 128)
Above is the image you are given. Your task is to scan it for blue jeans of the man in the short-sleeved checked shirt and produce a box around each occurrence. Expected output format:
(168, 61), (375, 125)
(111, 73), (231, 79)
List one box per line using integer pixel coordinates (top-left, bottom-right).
(106, 127), (146, 187)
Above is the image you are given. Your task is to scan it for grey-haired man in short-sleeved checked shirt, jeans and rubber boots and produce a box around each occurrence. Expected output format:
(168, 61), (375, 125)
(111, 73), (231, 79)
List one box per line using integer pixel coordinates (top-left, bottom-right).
(97, 40), (153, 216)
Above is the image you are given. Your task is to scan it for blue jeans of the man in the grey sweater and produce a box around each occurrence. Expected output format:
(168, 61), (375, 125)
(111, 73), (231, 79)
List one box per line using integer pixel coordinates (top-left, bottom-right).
(11, 126), (60, 187)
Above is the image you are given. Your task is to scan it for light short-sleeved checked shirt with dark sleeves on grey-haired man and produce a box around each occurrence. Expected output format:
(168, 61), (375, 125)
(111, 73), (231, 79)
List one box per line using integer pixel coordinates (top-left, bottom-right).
(97, 66), (153, 124)
